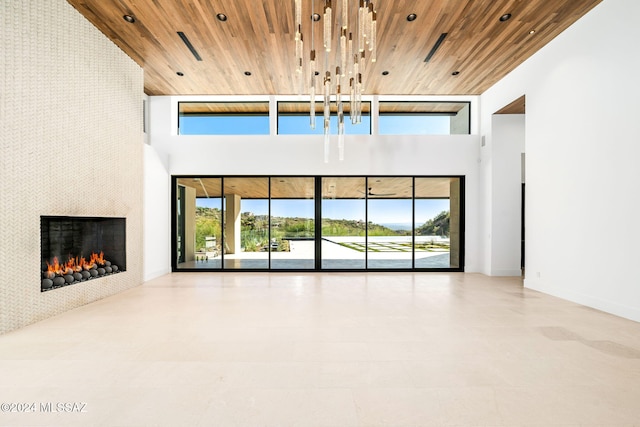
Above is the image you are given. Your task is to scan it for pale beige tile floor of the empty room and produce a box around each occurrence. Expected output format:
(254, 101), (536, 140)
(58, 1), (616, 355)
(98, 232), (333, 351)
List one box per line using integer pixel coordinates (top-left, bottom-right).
(0, 273), (640, 427)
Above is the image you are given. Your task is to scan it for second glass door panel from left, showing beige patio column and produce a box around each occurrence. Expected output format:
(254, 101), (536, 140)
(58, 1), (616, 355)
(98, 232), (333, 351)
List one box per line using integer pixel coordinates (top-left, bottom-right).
(223, 177), (269, 269)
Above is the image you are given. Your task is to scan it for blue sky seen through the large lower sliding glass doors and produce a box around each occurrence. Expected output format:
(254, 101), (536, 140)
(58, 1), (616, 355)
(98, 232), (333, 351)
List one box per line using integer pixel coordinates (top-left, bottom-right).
(197, 198), (449, 224)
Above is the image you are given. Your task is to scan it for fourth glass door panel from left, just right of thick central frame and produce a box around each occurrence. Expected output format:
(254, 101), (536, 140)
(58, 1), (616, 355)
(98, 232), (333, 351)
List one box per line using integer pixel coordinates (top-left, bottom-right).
(321, 177), (367, 270)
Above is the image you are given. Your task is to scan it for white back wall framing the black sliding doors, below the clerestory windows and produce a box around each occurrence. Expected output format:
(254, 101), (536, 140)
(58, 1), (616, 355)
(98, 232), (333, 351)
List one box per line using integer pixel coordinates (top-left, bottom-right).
(146, 97), (480, 271)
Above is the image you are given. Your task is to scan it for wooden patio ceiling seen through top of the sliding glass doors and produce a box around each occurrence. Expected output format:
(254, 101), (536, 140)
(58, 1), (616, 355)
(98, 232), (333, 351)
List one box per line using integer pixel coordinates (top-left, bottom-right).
(178, 176), (455, 199)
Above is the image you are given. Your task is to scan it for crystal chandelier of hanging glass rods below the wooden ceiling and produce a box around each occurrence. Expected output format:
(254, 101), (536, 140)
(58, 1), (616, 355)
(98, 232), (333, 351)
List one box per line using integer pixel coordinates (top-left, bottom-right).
(295, 0), (377, 162)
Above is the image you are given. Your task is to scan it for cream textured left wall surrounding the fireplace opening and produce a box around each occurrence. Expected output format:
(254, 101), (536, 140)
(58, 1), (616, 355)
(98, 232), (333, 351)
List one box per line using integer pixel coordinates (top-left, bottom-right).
(0, 0), (143, 333)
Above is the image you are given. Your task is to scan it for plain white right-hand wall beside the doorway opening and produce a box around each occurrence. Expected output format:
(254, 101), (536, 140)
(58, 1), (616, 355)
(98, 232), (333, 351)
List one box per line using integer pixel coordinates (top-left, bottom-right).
(481, 0), (640, 321)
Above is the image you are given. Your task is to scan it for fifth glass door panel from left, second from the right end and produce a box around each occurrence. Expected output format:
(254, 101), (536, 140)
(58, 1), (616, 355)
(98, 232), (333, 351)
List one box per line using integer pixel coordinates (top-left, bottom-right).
(367, 177), (413, 269)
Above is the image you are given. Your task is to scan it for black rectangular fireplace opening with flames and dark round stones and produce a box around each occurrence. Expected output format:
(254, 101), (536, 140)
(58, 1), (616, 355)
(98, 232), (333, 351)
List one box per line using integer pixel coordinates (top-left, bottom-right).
(40, 216), (127, 292)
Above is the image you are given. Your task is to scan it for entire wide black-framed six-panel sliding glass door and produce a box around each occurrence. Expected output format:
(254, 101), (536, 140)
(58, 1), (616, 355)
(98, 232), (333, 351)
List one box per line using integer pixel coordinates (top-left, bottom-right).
(172, 176), (464, 271)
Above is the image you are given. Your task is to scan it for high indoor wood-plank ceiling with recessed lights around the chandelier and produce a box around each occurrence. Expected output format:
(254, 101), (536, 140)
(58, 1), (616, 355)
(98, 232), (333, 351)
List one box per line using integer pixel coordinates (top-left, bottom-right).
(68, 0), (602, 95)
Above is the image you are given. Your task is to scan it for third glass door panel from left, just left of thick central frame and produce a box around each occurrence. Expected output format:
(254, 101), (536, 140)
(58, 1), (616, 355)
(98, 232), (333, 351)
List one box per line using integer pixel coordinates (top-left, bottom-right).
(269, 177), (315, 270)
